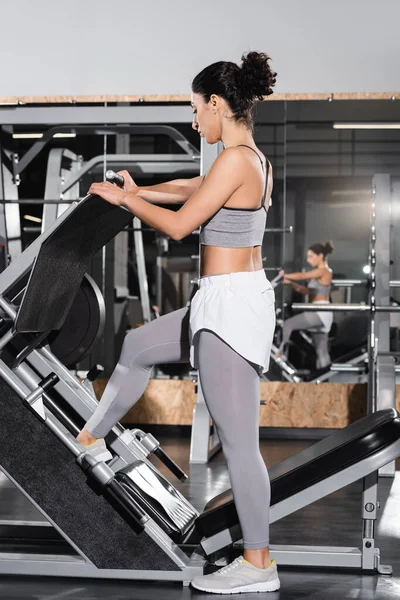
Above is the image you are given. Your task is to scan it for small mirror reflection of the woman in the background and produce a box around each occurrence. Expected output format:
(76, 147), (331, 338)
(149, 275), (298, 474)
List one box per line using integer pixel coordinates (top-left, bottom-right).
(277, 242), (333, 369)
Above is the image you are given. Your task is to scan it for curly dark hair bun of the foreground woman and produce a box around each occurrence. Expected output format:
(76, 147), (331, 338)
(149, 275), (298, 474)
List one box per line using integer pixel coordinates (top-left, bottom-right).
(240, 52), (276, 101)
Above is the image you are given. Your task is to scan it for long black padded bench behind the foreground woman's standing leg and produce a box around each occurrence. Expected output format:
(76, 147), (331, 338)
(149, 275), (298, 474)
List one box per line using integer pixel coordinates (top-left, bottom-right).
(196, 409), (400, 537)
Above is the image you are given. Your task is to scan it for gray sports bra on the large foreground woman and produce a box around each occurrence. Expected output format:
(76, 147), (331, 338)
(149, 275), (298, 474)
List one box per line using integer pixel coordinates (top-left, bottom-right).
(200, 144), (269, 248)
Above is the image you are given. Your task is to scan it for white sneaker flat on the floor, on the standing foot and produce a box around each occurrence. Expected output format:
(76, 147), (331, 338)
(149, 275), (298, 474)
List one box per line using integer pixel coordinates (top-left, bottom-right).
(192, 556), (281, 594)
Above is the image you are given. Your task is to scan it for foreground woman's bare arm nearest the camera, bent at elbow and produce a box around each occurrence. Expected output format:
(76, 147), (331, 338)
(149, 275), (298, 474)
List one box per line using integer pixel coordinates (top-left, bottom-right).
(89, 148), (246, 240)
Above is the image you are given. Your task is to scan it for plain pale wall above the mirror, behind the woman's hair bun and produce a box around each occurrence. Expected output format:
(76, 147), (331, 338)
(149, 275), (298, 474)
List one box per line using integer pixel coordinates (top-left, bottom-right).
(0, 0), (400, 97)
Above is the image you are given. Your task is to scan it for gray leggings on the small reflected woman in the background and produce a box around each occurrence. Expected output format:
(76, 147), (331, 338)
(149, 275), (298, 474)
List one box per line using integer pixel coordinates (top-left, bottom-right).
(279, 312), (331, 369)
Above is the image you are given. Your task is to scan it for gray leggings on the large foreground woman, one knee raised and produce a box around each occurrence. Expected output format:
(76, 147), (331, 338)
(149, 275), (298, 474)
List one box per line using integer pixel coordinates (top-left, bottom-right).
(86, 308), (271, 549)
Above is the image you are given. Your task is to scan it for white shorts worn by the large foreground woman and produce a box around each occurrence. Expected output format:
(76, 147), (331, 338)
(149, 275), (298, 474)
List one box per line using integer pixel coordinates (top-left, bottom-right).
(189, 269), (275, 373)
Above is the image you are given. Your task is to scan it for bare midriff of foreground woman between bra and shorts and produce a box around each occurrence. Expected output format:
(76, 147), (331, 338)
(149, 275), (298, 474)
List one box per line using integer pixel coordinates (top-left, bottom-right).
(200, 245), (263, 277)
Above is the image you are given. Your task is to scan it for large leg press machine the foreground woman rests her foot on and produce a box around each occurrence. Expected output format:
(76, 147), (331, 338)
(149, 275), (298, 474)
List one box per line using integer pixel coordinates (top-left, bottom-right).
(0, 184), (400, 583)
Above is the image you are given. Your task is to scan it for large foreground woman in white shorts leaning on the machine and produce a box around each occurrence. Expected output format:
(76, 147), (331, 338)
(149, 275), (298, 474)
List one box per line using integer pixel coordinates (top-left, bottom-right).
(78, 52), (280, 593)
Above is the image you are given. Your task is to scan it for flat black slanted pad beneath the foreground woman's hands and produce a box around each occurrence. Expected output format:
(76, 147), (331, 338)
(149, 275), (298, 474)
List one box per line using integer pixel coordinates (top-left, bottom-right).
(15, 195), (133, 333)
